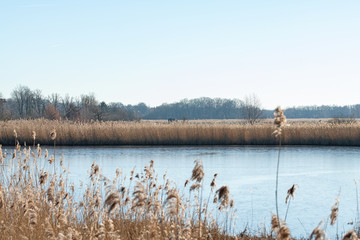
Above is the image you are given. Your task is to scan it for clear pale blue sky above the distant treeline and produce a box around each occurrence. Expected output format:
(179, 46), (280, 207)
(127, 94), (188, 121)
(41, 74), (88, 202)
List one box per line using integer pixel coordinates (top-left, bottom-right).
(0, 0), (360, 109)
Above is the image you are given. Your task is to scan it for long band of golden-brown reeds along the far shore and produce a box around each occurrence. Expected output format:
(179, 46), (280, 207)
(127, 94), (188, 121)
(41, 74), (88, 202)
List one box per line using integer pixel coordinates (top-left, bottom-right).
(0, 119), (360, 146)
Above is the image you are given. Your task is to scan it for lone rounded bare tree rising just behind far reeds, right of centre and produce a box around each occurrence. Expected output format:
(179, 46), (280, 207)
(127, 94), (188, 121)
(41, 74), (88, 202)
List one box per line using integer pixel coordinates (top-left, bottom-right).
(243, 94), (263, 124)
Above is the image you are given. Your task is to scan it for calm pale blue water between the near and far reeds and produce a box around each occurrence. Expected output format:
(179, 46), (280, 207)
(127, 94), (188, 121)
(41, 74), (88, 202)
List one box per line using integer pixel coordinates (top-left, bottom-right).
(4, 146), (360, 239)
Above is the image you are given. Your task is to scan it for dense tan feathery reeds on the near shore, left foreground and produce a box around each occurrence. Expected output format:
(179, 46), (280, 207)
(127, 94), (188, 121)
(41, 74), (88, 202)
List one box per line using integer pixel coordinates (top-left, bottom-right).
(0, 143), (272, 240)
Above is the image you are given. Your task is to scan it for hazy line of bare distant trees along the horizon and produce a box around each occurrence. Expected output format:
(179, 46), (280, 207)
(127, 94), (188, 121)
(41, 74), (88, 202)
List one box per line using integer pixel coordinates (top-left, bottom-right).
(0, 86), (360, 123)
